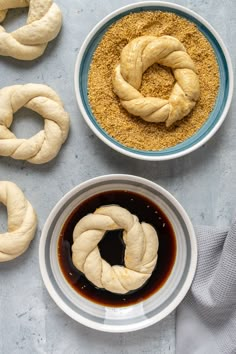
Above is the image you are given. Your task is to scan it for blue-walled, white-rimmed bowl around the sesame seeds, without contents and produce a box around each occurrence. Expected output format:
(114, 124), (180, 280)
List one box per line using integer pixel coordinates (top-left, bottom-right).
(74, 1), (233, 161)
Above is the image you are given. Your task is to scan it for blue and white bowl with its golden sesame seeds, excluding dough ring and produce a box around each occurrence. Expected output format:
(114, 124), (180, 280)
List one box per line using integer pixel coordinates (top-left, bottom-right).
(74, 1), (233, 161)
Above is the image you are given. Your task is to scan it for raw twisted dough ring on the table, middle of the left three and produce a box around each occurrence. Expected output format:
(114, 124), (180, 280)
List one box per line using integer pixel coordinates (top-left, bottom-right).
(0, 84), (70, 164)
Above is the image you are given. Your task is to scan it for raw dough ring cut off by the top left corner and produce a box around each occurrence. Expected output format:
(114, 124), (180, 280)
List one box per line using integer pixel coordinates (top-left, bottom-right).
(0, 0), (62, 60)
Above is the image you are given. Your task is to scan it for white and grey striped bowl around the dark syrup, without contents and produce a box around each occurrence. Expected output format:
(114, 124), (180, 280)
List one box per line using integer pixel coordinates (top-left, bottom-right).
(39, 174), (197, 332)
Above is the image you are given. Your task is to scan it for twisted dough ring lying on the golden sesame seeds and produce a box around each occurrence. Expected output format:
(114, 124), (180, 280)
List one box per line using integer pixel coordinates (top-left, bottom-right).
(113, 36), (200, 127)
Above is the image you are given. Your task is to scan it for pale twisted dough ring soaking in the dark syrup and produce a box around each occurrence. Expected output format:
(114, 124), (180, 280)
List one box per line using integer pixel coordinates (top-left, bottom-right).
(72, 205), (159, 294)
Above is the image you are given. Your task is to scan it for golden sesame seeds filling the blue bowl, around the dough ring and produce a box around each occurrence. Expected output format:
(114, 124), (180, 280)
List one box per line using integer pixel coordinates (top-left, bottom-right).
(88, 11), (219, 150)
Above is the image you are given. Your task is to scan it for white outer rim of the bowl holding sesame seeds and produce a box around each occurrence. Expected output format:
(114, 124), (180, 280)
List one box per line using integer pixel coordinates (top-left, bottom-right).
(74, 1), (234, 161)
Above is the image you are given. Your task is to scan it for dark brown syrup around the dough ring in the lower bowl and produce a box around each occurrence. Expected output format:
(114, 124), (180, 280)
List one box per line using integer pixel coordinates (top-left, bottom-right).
(58, 190), (176, 307)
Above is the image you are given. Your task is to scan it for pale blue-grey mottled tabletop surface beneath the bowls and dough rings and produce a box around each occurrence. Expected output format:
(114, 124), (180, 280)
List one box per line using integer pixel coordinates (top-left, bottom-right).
(0, 0), (236, 354)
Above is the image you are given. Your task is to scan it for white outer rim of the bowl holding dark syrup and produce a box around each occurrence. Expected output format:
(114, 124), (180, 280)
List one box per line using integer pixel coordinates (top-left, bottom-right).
(39, 174), (198, 333)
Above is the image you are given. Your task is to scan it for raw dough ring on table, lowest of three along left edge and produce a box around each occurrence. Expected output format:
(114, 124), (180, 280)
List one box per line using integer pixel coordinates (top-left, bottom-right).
(0, 181), (37, 262)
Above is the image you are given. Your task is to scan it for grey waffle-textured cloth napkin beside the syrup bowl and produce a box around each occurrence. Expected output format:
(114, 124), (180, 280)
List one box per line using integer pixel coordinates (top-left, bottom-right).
(176, 220), (236, 354)
